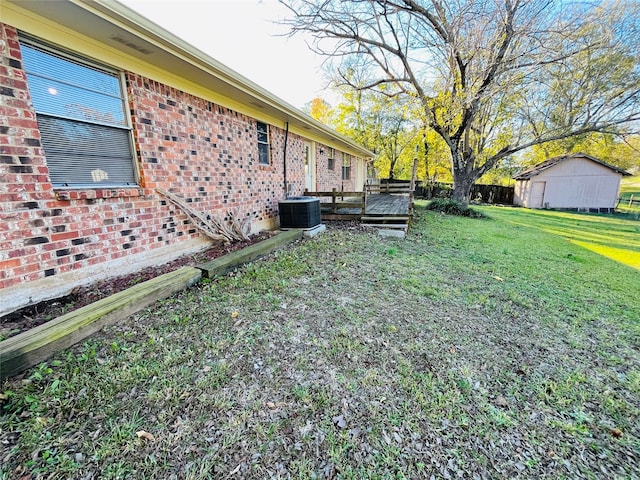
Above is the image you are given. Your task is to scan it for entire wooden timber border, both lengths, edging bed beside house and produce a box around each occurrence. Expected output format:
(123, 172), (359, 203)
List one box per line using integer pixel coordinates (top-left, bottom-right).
(0, 229), (302, 382)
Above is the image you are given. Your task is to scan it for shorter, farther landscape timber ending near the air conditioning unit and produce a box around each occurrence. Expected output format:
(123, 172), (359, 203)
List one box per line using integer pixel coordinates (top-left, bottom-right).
(197, 228), (302, 278)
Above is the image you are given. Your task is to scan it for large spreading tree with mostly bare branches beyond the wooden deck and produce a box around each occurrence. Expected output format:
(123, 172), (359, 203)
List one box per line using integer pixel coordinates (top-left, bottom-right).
(280, 0), (640, 201)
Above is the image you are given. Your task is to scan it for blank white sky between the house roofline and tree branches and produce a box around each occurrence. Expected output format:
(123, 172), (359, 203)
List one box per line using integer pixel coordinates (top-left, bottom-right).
(119, 0), (330, 108)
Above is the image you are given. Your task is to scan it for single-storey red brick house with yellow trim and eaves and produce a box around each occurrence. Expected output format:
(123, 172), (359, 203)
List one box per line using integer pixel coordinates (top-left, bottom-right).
(0, 0), (372, 315)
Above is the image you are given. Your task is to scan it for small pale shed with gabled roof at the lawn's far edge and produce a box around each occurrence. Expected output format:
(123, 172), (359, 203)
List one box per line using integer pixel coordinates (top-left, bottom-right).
(513, 153), (630, 213)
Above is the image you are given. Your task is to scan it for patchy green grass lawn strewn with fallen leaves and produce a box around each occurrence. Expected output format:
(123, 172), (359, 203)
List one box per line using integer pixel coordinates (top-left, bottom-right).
(0, 206), (640, 479)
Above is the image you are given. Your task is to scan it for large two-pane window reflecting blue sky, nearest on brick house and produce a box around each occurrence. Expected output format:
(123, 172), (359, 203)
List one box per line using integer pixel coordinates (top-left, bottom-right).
(21, 39), (136, 188)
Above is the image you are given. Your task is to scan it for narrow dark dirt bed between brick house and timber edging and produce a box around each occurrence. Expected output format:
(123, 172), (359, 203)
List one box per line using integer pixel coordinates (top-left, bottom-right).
(0, 232), (272, 339)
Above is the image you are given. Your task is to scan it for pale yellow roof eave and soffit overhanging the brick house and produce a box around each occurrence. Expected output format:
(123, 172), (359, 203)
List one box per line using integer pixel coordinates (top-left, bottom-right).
(2, 0), (375, 157)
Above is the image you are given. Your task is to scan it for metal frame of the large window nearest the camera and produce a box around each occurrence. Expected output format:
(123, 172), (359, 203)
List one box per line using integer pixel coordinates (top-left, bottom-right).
(18, 32), (140, 190)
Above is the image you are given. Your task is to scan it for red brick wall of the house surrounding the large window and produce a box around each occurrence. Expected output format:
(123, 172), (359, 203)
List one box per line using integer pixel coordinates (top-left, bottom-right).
(0, 24), (314, 304)
